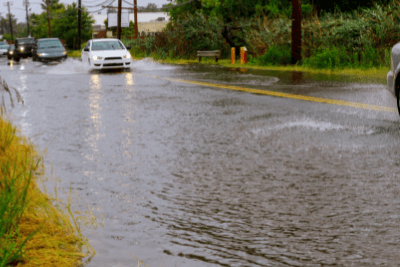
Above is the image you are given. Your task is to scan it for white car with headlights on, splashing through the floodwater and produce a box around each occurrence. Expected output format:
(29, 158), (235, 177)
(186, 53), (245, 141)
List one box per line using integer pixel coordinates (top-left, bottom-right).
(81, 38), (132, 70)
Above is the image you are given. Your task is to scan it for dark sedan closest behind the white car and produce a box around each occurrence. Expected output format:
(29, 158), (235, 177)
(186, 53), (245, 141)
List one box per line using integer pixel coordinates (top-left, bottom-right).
(32, 38), (68, 62)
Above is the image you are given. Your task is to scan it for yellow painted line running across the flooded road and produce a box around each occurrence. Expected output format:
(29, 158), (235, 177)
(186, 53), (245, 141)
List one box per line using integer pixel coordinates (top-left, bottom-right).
(137, 75), (397, 113)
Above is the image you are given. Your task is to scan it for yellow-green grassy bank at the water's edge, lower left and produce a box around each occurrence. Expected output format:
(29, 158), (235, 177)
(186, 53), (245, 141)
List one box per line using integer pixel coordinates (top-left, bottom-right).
(0, 79), (91, 267)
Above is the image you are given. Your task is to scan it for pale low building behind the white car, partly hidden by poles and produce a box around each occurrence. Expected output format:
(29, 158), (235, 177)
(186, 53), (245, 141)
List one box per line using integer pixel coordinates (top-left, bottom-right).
(92, 12), (169, 38)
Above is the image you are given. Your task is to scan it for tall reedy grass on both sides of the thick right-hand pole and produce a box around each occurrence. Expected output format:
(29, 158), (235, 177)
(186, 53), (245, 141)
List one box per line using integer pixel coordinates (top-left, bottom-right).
(244, 1), (400, 68)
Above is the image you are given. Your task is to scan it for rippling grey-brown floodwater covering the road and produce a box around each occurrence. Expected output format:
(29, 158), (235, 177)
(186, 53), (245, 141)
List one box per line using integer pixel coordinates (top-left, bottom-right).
(0, 58), (400, 267)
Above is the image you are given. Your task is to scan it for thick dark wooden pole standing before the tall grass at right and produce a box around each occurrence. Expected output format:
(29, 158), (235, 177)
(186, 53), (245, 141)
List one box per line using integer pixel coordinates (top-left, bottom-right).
(291, 0), (301, 64)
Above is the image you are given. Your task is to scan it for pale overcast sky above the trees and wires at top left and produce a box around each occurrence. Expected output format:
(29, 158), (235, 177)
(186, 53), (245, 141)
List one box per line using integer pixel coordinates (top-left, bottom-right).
(0, 0), (169, 22)
